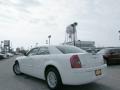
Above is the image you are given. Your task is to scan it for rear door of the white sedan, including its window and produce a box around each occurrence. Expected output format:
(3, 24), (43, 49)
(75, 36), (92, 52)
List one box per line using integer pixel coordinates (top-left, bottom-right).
(33, 47), (50, 78)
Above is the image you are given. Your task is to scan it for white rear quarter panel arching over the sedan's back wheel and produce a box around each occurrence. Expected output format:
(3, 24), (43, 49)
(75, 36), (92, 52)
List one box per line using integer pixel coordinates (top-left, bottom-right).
(43, 54), (71, 79)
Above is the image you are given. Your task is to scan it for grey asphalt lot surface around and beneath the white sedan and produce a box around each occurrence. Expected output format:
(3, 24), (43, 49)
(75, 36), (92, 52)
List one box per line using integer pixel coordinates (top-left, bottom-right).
(0, 56), (120, 90)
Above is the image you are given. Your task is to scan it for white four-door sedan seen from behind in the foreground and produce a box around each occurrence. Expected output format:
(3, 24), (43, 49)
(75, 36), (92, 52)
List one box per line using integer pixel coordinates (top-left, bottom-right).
(13, 45), (106, 90)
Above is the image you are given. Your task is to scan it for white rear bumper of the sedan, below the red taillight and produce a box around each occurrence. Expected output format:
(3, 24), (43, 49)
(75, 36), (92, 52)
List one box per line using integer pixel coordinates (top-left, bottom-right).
(61, 64), (107, 85)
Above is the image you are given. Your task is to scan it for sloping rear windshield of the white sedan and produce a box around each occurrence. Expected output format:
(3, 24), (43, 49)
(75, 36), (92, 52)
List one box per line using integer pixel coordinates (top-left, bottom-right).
(56, 46), (87, 54)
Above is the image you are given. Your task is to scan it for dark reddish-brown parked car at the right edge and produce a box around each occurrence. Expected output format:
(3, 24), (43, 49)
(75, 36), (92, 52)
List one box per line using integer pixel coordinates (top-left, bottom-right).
(98, 48), (120, 65)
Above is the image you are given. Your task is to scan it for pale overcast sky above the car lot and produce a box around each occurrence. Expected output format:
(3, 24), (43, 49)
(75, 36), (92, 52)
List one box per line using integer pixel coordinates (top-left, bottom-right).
(0, 0), (120, 48)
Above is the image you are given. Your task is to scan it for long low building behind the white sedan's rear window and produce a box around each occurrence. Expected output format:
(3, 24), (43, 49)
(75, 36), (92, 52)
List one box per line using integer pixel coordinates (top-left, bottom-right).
(63, 40), (95, 50)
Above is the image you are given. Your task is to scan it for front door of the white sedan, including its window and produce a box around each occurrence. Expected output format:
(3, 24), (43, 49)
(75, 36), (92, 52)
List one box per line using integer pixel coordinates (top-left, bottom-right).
(22, 48), (39, 75)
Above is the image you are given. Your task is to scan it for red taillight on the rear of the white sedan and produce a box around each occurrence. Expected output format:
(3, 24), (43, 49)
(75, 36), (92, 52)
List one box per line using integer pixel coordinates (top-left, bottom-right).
(70, 55), (82, 68)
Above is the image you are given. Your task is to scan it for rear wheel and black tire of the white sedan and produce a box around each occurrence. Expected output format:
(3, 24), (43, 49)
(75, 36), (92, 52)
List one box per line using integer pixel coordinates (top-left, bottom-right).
(46, 68), (62, 90)
